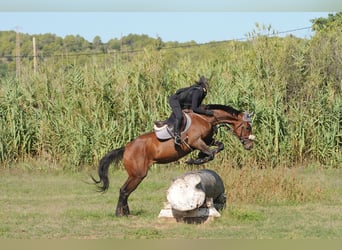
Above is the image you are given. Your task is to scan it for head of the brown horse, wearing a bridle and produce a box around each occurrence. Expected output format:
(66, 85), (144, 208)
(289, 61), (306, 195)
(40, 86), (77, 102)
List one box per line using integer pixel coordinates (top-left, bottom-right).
(233, 112), (255, 150)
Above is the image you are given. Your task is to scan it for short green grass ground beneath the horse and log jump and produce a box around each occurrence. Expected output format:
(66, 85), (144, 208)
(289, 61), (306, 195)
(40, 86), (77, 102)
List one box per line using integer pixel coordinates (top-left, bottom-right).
(0, 165), (342, 239)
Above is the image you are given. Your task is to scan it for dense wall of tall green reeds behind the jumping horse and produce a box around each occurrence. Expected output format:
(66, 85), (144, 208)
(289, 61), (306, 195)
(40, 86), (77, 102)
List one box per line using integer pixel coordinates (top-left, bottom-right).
(0, 18), (342, 170)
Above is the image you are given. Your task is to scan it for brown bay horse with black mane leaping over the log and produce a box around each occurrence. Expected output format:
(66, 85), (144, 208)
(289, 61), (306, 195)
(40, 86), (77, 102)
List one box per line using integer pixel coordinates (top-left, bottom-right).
(91, 104), (255, 216)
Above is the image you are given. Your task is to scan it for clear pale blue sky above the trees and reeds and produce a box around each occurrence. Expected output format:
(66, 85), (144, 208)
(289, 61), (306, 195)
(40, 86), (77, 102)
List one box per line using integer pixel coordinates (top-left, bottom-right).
(0, 11), (332, 43)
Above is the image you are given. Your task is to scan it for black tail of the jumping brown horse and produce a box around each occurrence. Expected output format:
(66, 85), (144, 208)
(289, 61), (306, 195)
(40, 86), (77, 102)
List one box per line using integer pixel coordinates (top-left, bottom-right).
(90, 147), (125, 192)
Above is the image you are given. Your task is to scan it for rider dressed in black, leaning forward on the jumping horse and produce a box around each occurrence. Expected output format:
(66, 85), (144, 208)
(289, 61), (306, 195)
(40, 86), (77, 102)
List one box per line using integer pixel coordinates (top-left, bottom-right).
(169, 76), (213, 145)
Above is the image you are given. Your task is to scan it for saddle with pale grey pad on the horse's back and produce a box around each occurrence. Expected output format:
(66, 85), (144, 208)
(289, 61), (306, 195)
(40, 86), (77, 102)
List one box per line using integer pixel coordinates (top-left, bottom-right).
(153, 112), (191, 140)
